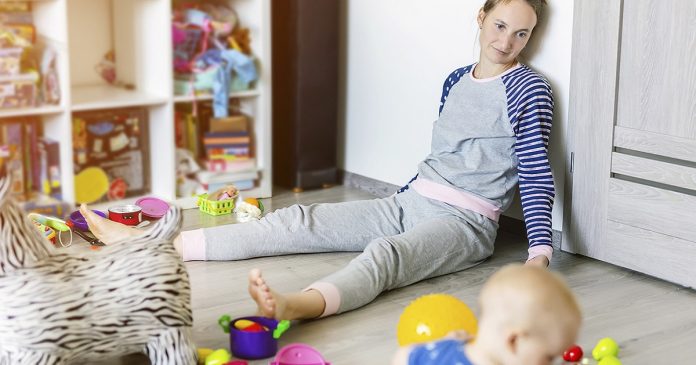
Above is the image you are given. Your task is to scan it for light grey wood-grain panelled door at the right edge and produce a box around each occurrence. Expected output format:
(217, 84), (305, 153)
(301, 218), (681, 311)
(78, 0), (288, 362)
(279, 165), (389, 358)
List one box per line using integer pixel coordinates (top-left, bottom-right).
(563, 0), (696, 287)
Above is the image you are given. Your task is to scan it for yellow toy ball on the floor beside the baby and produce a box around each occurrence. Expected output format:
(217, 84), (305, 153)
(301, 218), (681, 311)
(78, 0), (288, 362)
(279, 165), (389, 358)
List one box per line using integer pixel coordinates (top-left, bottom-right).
(396, 294), (478, 346)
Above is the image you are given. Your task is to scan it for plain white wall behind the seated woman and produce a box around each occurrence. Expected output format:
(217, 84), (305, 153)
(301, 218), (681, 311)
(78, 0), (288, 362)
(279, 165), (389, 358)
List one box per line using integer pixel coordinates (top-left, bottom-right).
(338, 0), (573, 230)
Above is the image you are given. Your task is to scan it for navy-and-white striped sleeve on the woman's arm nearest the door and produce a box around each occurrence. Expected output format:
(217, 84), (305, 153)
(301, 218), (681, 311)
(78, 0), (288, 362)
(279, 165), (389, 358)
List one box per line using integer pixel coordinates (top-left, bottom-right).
(511, 74), (555, 261)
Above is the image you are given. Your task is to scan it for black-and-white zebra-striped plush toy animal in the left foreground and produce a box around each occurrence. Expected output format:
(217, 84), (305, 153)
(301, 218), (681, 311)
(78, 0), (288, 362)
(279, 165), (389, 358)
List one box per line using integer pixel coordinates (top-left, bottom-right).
(0, 178), (196, 365)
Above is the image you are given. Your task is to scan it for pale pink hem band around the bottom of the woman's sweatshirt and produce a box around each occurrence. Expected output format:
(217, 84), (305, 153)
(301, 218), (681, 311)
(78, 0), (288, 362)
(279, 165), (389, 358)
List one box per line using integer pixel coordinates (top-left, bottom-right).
(410, 177), (502, 222)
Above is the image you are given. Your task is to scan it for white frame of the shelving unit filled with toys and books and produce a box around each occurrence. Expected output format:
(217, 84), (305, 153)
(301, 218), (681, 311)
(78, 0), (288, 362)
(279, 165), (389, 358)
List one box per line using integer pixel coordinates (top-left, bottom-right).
(0, 0), (272, 203)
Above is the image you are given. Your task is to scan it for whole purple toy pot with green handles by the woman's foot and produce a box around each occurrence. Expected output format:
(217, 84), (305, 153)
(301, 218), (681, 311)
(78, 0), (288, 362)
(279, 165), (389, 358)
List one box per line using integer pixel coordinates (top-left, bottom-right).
(218, 315), (290, 359)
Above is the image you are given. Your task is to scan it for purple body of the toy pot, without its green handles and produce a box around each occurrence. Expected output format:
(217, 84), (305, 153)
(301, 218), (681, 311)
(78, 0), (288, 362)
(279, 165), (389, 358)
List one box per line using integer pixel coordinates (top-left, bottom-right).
(230, 316), (278, 360)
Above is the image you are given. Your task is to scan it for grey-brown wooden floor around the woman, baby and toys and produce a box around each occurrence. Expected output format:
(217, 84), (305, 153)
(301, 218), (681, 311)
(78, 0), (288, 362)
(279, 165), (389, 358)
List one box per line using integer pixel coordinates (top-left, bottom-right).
(72, 186), (696, 365)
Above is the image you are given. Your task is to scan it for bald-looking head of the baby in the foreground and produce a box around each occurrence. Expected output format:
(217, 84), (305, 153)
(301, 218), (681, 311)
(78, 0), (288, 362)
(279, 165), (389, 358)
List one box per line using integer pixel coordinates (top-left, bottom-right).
(476, 265), (582, 365)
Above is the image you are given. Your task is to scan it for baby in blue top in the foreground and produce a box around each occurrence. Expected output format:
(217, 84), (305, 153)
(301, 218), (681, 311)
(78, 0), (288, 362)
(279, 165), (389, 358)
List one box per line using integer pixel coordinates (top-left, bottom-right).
(393, 265), (582, 365)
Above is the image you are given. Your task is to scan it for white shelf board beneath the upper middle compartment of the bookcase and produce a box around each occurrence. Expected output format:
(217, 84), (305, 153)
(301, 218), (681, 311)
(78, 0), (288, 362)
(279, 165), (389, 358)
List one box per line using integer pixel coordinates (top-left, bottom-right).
(71, 85), (168, 111)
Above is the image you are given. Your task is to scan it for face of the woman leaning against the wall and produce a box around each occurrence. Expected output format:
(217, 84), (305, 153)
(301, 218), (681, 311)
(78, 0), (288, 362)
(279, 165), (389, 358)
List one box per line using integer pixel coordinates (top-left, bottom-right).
(478, 0), (537, 65)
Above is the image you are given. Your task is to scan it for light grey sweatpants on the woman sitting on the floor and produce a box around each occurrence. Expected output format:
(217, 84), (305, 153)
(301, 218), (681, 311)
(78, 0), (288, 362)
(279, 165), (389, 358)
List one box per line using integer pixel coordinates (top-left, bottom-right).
(203, 190), (498, 313)
